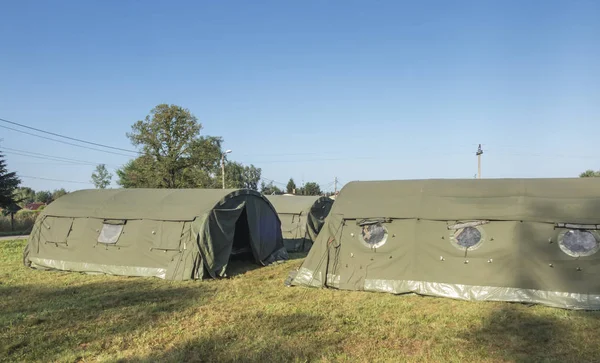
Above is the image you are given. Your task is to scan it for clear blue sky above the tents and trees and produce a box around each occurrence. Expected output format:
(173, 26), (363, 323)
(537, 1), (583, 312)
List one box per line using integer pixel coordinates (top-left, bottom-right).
(0, 0), (600, 190)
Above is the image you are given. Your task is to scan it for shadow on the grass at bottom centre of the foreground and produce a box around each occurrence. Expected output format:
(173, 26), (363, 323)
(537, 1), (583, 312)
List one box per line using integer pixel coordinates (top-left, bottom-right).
(126, 313), (343, 363)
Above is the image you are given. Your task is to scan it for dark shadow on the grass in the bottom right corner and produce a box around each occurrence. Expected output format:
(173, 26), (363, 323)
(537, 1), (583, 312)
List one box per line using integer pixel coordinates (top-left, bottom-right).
(463, 304), (600, 362)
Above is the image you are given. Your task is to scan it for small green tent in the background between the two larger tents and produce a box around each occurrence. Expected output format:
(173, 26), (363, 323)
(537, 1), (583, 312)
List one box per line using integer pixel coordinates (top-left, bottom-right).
(267, 195), (333, 252)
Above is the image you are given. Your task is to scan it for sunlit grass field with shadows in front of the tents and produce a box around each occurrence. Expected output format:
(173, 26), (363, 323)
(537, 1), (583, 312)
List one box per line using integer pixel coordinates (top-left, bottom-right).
(0, 241), (600, 362)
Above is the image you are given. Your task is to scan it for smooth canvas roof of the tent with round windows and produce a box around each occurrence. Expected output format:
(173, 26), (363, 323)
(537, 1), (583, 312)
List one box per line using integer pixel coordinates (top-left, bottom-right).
(332, 178), (600, 223)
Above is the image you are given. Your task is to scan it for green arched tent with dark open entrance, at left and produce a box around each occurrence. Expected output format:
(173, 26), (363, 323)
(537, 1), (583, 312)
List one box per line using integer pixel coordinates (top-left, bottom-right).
(24, 189), (287, 280)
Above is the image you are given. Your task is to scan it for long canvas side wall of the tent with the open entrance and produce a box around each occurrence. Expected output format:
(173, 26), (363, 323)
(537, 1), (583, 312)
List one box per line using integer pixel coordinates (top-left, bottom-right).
(24, 216), (202, 280)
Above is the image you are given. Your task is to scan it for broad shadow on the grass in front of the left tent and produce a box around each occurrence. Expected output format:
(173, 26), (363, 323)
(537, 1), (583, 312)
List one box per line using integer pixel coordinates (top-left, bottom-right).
(0, 279), (214, 361)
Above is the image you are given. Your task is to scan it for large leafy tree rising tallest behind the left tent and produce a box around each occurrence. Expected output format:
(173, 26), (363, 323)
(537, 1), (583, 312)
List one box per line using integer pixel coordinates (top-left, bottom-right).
(117, 104), (223, 188)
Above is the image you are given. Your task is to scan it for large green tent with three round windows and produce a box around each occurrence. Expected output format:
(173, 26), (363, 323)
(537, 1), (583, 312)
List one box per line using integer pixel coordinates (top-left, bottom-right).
(288, 178), (600, 309)
